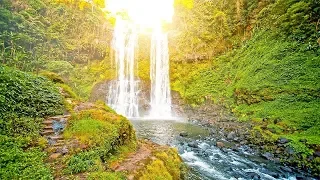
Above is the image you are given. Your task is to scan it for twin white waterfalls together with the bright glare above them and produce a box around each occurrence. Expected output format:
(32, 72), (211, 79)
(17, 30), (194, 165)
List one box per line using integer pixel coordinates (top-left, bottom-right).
(106, 0), (174, 119)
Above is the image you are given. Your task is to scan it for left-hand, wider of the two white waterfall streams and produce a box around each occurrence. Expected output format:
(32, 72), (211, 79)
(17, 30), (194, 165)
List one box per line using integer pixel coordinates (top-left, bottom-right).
(108, 17), (139, 118)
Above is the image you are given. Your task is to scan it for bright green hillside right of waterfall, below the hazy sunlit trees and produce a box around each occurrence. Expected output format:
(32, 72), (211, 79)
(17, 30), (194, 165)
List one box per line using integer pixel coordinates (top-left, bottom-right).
(171, 0), (320, 173)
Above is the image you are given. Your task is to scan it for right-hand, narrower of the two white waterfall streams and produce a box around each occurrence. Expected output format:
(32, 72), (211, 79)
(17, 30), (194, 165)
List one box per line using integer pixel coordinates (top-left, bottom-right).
(150, 28), (171, 119)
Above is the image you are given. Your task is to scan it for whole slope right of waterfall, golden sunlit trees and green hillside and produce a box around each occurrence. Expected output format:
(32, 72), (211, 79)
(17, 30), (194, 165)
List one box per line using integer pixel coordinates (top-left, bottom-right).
(171, 0), (320, 173)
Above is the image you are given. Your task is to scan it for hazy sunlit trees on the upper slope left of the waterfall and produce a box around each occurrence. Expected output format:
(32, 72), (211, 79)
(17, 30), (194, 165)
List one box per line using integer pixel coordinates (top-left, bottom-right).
(0, 0), (111, 71)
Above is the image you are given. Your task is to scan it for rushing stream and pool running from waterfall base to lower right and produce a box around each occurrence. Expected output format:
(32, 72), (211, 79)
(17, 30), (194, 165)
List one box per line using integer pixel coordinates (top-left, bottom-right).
(131, 120), (313, 180)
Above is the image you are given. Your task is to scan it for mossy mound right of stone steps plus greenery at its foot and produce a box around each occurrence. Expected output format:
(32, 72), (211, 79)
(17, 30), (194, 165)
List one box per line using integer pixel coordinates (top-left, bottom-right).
(64, 103), (136, 175)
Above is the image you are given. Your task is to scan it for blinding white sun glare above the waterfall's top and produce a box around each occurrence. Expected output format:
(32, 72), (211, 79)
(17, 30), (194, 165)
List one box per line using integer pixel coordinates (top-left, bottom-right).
(106, 0), (174, 28)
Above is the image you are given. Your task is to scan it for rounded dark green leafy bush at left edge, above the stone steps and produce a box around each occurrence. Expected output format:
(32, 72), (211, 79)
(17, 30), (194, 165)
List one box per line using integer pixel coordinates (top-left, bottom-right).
(0, 66), (63, 119)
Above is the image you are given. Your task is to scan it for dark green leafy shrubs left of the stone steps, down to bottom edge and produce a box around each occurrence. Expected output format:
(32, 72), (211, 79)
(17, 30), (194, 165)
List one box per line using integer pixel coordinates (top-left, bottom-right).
(0, 66), (63, 179)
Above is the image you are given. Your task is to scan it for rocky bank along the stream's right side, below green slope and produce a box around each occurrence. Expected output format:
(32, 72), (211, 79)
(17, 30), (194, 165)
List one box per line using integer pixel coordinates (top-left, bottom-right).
(172, 92), (320, 179)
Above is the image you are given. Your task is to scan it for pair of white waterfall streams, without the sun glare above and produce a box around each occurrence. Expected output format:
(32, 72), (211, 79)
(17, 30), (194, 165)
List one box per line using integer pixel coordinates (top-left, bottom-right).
(108, 17), (172, 119)
